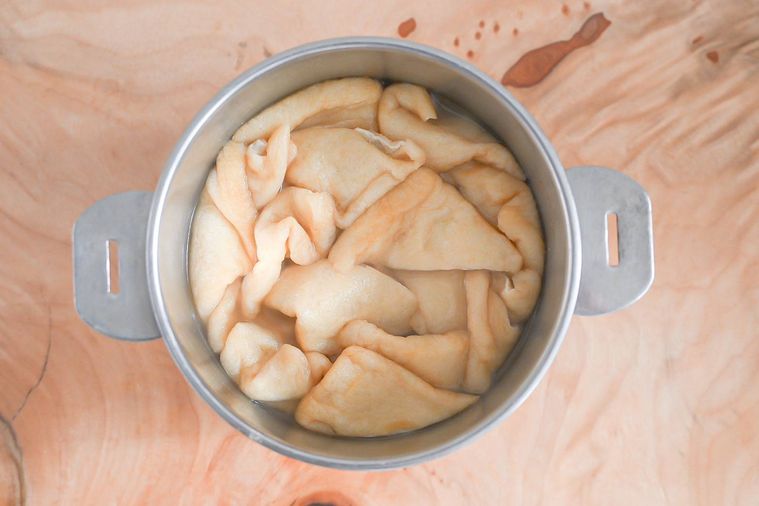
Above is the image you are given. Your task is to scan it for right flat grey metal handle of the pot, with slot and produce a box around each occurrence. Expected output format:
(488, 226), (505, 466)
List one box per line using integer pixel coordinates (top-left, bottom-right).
(567, 167), (654, 316)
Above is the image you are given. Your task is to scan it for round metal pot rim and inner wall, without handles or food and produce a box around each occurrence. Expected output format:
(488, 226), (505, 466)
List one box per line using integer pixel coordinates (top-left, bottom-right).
(148, 38), (579, 469)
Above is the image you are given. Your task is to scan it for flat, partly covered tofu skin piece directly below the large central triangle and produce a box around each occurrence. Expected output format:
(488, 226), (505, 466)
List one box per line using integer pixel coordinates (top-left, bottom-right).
(390, 271), (467, 334)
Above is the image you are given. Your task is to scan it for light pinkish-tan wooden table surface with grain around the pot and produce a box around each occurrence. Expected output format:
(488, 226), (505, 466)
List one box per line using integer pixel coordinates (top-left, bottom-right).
(0, 0), (759, 505)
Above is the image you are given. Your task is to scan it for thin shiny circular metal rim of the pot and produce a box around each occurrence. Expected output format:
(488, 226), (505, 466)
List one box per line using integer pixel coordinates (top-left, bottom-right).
(146, 37), (581, 470)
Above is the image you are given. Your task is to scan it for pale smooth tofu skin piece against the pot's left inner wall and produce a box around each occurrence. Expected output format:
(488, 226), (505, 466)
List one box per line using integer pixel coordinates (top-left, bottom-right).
(189, 192), (252, 322)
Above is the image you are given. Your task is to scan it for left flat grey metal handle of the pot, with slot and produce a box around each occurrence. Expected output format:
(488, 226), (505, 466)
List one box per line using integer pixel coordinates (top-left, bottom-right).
(72, 192), (161, 341)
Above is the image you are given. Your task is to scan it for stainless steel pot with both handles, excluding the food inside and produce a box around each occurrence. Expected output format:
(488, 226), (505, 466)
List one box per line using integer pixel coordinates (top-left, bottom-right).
(73, 38), (654, 469)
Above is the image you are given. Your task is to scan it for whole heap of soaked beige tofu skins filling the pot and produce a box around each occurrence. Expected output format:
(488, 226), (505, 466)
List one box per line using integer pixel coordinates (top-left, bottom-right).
(188, 78), (545, 437)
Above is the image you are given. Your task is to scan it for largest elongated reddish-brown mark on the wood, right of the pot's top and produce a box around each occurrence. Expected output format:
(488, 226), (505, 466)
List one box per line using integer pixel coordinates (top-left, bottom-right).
(501, 12), (611, 88)
